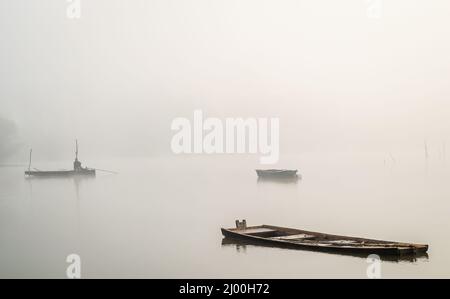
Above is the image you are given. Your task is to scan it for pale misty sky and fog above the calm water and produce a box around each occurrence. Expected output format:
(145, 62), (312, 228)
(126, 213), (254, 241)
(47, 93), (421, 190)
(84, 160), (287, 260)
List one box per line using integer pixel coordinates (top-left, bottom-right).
(0, 0), (450, 159)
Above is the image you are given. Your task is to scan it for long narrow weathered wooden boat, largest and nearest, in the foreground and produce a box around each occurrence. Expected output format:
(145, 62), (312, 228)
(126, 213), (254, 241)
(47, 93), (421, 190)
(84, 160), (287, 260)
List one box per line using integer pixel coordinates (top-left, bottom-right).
(221, 220), (428, 256)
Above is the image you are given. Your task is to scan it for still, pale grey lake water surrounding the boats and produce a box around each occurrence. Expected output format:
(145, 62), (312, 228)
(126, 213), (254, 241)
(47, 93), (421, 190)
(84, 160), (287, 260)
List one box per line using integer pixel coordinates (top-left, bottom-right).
(0, 153), (450, 278)
